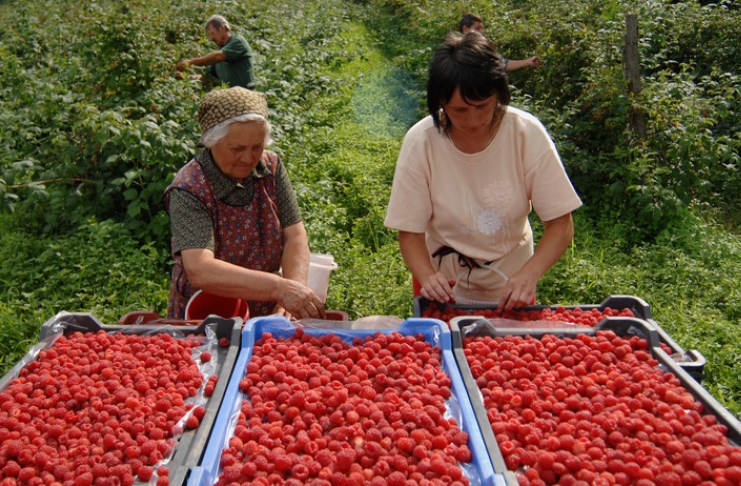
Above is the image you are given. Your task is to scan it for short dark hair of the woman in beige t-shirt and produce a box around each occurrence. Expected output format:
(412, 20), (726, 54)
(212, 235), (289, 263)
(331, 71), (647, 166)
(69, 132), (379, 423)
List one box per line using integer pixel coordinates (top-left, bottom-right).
(427, 32), (510, 134)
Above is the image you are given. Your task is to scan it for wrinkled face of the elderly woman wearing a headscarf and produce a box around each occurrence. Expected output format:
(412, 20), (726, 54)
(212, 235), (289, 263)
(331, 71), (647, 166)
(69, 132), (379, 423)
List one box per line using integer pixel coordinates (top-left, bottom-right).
(211, 121), (268, 181)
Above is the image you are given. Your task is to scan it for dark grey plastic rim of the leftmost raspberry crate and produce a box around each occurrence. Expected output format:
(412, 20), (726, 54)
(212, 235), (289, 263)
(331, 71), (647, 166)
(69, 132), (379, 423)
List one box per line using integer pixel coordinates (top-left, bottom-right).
(21, 312), (242, 485)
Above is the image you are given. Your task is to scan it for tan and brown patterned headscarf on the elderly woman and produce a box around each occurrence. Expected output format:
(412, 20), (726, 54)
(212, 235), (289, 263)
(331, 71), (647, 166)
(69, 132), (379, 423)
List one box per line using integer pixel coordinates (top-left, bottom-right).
(198, 86), (268, 133)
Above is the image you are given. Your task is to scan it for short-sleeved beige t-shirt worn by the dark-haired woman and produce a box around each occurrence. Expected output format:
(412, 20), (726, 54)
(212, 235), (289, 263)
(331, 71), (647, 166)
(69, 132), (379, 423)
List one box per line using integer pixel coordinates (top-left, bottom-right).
(385, 106), (582, 262)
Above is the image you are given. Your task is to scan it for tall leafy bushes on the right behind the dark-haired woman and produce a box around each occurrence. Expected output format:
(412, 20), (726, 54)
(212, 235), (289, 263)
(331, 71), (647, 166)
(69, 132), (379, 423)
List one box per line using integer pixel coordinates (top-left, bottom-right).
(356, 0), (741, 243)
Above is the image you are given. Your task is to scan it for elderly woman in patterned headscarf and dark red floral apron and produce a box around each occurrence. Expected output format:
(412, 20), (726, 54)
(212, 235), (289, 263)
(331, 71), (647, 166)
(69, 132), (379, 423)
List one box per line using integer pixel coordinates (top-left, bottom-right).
(164, 87), (324, 319)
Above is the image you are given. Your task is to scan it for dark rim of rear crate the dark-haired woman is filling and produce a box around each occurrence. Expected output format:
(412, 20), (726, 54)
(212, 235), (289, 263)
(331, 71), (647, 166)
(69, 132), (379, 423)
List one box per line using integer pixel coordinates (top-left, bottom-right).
(413, 295), (707, 383)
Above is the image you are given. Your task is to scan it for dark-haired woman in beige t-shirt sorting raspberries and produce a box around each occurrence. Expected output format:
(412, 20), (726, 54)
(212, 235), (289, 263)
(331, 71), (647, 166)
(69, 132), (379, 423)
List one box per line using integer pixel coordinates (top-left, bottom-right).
(385, 32), (581, 309)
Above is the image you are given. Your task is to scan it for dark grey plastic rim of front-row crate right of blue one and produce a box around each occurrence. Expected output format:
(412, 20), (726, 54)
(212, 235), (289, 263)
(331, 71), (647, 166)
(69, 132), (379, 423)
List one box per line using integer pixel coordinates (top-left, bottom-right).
(450, 316), (741, 486)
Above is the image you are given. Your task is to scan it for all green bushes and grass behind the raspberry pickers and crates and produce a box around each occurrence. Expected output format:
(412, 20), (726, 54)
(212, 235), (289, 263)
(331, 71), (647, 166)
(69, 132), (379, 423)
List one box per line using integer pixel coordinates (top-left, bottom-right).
(0, 0), (741, 415)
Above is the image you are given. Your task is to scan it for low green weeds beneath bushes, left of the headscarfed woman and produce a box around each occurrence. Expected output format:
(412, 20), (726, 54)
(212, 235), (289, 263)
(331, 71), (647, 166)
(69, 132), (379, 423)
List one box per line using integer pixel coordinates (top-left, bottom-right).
(0, 215), (169, 368)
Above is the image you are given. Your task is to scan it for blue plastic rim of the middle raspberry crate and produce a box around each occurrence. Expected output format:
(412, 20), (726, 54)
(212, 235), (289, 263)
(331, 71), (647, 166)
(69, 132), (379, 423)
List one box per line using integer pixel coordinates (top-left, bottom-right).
(188, 317), (505, 486)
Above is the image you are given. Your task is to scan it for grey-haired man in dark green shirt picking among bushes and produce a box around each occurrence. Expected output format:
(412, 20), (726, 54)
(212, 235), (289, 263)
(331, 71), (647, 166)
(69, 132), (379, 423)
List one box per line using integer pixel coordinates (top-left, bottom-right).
(175, 15), (255, 89)
